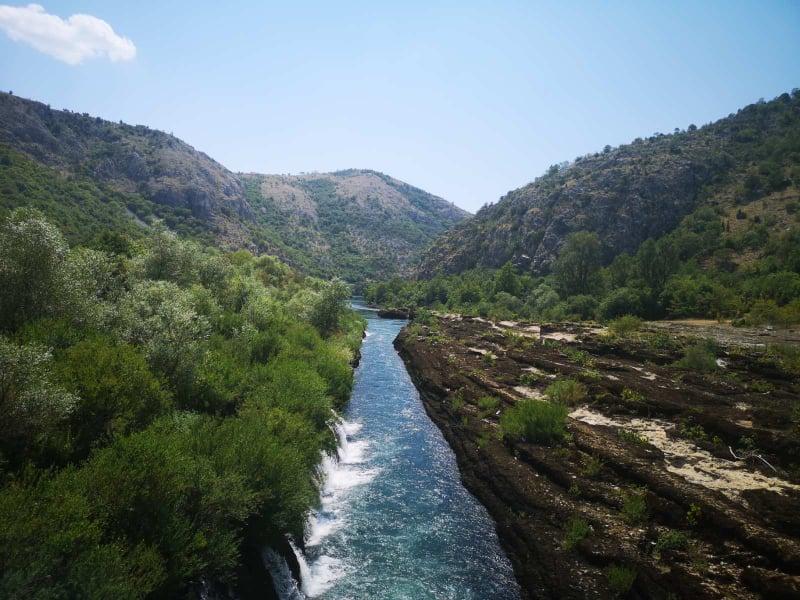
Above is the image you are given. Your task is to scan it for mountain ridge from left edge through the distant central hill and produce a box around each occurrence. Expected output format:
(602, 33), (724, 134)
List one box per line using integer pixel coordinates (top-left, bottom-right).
(0, 94), (468, 281)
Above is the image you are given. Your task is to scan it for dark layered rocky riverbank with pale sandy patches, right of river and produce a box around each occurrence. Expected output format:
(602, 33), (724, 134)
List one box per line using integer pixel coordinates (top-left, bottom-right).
(395, 315), (800, 599)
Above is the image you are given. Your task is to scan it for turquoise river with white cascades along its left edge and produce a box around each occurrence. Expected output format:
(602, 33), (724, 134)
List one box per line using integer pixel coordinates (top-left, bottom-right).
(290, 305), (519, 600)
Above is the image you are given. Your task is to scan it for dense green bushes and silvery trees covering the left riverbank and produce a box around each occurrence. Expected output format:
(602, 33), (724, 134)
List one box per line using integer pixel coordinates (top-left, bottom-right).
(0, 209), (363, 598)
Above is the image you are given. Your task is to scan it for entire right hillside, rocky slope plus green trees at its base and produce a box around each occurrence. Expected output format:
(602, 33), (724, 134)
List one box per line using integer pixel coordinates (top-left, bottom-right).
(374, 92), (800, 325)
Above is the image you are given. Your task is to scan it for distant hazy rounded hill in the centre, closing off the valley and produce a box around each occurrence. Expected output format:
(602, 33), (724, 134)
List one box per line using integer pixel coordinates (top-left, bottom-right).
(242, 169), (467, 279)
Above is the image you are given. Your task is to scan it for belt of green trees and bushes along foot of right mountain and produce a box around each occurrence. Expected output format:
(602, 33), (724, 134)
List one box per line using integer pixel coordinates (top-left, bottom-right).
(366, 202), (800, 326)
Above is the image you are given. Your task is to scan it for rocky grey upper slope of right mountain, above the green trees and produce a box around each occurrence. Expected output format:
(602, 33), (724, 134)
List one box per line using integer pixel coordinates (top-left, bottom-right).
(417, 90), (800, 276)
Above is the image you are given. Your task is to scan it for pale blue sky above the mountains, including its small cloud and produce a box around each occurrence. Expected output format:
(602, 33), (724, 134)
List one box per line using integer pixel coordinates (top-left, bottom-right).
(0, 0), (800, 212)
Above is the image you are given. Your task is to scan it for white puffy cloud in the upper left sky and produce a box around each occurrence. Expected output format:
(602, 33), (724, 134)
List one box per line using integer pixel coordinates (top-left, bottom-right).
(0, 4), (136, 65)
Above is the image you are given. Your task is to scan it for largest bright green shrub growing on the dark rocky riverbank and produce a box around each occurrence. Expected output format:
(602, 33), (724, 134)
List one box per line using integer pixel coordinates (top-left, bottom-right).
(500, 398), (568, 445)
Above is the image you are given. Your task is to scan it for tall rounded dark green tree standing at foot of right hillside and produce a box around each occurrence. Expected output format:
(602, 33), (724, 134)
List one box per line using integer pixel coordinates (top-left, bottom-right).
(554, 231), (600, 296)
